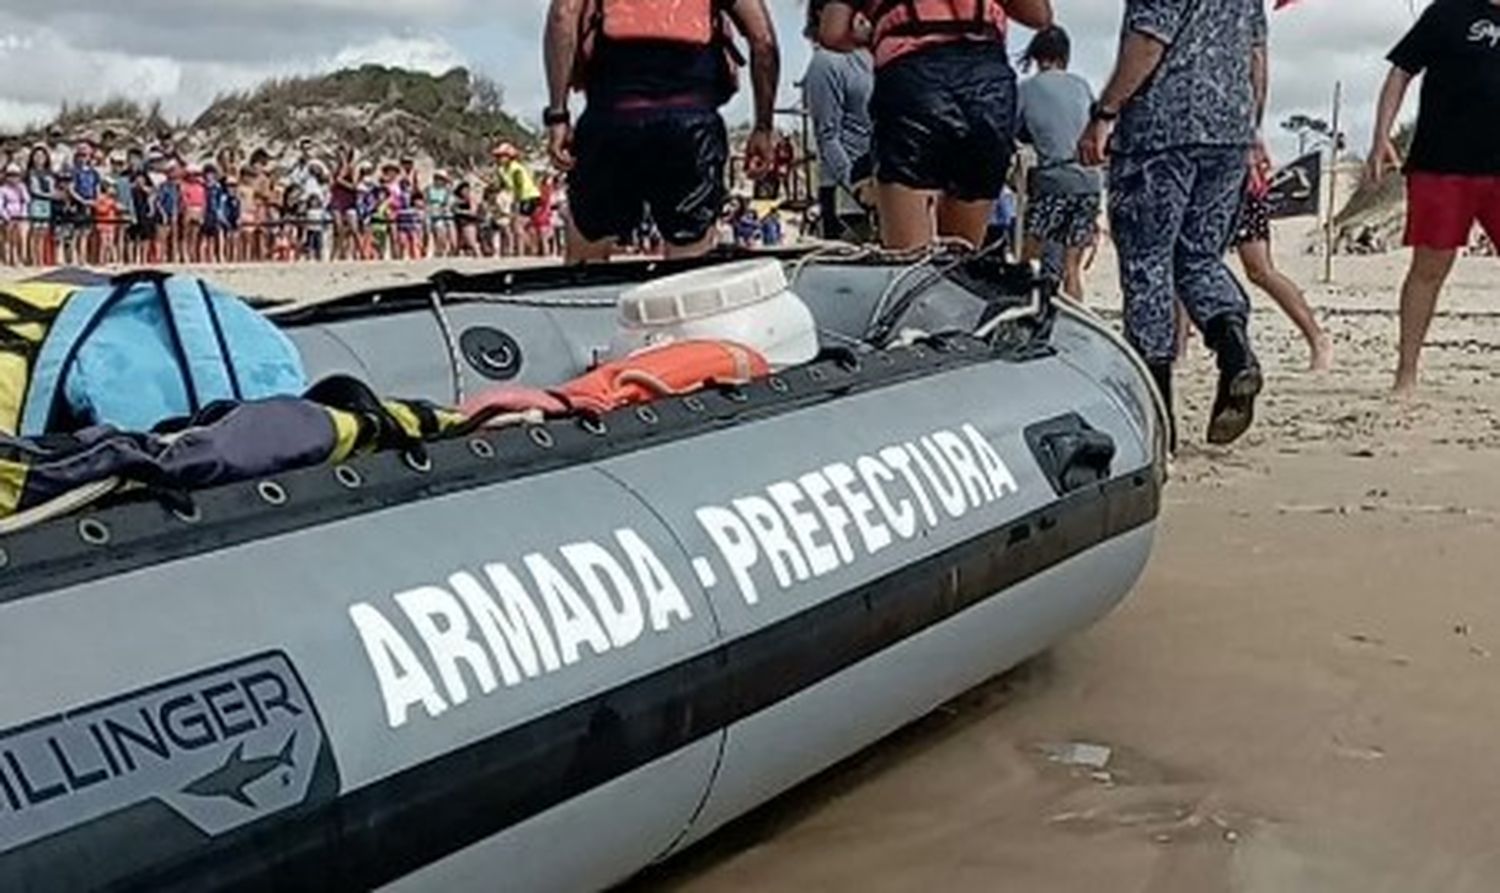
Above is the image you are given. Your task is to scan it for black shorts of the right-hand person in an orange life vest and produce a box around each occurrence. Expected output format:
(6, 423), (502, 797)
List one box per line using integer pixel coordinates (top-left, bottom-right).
(870, 42), (1016, 201)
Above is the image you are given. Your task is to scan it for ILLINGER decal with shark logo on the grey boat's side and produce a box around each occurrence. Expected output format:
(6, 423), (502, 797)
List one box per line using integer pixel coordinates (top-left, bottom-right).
(0, 653), (339, 864)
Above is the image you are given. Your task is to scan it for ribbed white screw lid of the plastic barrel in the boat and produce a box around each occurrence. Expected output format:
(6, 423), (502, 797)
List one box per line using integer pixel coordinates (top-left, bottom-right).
(620, 258), (788, 327)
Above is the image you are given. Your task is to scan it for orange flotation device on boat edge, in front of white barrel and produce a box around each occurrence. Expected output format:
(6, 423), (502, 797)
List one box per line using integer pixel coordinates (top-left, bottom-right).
(554, 341), (771, 416)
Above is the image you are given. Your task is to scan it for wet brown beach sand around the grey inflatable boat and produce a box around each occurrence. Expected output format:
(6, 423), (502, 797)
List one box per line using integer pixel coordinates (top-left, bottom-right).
(58, 233), (1500, 893)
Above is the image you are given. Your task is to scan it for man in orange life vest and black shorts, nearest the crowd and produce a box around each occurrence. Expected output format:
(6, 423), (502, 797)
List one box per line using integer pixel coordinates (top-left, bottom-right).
(543, 0), (780, 263)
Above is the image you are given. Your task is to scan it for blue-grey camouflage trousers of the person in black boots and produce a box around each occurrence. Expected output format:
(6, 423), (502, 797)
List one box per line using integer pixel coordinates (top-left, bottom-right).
(1110, 146), (1250, 363)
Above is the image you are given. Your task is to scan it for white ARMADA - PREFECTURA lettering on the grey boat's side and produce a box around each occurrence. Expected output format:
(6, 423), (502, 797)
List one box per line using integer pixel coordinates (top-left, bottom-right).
(350, 425), (1019, 728)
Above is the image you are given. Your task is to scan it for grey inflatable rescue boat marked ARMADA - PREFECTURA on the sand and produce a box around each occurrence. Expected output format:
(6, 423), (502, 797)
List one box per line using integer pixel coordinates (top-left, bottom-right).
(0, 254), (1166, 893)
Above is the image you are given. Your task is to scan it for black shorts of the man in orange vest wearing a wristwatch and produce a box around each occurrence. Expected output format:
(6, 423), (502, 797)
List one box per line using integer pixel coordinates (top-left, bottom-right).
(569, 108), (729, 248)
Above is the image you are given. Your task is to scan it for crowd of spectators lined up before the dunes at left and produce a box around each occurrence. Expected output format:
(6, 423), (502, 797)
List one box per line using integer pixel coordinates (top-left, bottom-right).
(0, 131), (567, 266)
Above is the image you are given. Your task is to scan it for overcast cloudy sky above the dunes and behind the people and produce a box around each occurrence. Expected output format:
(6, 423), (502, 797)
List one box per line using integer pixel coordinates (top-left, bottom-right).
(0, 0), (1412, 159)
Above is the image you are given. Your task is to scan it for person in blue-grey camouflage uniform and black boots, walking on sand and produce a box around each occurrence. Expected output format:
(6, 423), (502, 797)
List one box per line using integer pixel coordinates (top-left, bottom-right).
(1079, 0), (1266, 444)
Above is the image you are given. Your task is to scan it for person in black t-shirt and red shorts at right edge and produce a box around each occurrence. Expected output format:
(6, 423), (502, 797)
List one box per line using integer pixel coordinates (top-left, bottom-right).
(1367, 0), (1500, 393)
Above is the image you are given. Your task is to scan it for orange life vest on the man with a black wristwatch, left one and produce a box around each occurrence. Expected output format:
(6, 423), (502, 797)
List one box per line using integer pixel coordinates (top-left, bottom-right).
(573, 0), (746, 92)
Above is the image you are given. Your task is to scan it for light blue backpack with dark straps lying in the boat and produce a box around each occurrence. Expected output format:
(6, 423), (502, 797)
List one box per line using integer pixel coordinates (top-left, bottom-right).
(20, 273), (308, 437)
